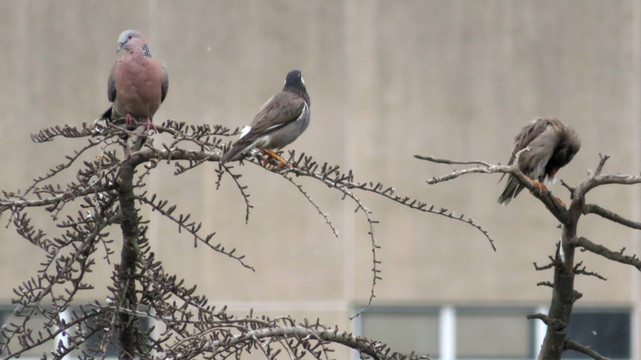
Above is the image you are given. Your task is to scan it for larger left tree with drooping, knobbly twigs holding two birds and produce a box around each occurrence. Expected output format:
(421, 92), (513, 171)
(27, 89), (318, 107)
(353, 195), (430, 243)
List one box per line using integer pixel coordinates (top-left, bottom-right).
(0, 121), (492, 359)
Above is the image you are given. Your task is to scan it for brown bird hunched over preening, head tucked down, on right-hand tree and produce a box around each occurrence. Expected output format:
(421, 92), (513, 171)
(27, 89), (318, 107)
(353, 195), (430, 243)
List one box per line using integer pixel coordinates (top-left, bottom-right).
(498, 119), (581, 205)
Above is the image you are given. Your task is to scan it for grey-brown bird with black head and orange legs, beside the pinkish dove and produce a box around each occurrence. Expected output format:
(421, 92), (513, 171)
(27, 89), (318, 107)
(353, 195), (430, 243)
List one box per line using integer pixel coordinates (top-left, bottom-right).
(220, 70), (310, 165)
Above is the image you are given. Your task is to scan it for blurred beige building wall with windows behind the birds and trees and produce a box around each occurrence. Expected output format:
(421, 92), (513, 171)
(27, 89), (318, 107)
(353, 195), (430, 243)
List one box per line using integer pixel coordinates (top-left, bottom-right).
(0, 0), (641, 359)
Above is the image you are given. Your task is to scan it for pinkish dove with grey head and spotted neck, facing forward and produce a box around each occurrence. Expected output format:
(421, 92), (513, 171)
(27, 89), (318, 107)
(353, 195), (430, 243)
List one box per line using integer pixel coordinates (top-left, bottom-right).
(100, 30), (169, 131)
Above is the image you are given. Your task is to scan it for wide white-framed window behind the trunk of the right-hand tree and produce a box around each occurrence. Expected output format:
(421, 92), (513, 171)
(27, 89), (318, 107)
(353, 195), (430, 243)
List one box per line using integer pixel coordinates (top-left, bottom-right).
(356, 306), (632, 360)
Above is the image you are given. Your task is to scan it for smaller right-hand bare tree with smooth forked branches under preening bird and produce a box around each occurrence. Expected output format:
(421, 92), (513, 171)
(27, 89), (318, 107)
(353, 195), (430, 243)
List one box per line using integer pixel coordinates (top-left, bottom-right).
(415, 155), (641, 359)
